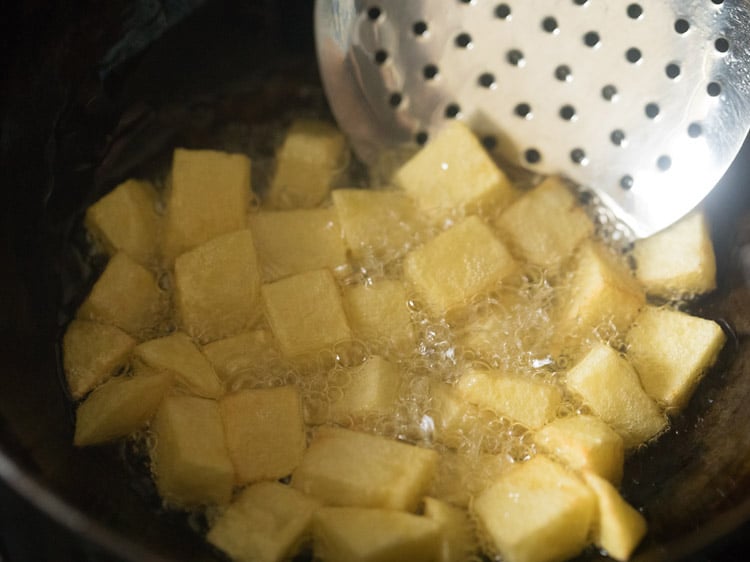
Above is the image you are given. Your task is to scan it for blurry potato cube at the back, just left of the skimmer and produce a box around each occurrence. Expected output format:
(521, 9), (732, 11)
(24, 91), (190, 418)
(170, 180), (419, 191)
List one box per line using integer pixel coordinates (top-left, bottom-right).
(267, 119), (346, 209)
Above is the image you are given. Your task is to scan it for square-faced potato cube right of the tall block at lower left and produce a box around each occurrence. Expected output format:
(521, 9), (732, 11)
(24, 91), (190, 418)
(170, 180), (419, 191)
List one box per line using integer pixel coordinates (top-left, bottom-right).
(219, 386), (305, 484)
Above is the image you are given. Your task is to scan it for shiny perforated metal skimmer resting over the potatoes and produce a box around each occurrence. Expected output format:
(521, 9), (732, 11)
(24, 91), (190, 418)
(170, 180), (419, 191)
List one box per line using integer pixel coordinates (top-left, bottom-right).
(315, 0), (750, 236)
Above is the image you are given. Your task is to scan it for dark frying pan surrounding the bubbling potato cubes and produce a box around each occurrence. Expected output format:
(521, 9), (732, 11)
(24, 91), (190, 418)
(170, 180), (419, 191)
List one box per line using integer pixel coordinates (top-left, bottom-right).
(0, 0), (750, 562)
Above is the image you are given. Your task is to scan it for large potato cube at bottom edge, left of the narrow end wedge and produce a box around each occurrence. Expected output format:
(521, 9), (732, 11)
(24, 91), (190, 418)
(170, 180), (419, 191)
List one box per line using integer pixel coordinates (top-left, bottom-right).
(472, 455), (596, 562)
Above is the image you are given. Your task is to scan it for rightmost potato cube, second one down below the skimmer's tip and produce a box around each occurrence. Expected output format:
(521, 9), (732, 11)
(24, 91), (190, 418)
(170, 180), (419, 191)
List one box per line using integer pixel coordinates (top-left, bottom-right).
(627, 306), (726, 409)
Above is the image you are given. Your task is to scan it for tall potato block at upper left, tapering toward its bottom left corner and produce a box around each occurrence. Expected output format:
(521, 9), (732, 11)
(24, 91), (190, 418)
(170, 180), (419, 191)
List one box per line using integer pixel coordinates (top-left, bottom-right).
(164, 148), (252, 263)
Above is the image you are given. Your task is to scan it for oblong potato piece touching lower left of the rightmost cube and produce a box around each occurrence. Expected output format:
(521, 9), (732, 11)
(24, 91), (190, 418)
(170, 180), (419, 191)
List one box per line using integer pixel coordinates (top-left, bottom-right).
(567, 343), (667, 449)
